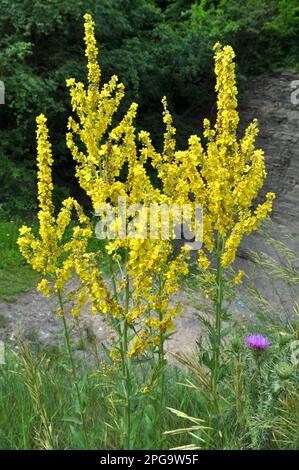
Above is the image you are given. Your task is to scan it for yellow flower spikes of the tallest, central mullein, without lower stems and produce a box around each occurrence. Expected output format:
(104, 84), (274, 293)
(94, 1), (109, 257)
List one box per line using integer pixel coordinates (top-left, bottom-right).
(67, 15), (193, 357)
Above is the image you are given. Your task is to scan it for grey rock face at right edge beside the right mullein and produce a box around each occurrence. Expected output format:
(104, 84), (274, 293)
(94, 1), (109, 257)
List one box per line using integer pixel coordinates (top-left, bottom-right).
(240, 72), (299, 231)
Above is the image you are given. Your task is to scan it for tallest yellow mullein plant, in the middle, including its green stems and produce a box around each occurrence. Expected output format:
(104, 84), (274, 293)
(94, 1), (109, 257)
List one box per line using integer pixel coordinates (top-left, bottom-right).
(66, 14), (195, 448)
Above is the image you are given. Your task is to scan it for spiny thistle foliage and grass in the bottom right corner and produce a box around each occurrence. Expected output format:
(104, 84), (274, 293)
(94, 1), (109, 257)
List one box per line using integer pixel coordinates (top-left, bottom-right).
(172, 328), (299, 449)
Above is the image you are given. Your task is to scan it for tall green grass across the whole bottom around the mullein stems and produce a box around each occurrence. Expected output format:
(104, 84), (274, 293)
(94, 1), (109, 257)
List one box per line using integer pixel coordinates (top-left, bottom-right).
(0, 322), (299, 450)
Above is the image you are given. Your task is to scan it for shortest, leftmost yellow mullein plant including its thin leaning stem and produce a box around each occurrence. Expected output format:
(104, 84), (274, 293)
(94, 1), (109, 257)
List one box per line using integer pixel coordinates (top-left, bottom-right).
(18, 115), (99, 443)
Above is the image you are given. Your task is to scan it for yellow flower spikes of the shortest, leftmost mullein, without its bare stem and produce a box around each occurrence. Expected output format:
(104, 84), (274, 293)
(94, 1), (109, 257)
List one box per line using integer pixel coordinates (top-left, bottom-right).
(18, 115), (113, 316)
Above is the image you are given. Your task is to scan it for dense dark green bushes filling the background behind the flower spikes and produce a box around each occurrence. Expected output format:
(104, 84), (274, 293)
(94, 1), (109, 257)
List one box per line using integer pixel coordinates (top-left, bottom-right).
(0, 0), (299, 212)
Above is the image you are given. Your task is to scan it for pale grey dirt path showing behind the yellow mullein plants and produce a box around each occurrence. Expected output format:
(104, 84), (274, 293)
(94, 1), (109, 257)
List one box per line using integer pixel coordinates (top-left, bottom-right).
(0, 242), (286, 360)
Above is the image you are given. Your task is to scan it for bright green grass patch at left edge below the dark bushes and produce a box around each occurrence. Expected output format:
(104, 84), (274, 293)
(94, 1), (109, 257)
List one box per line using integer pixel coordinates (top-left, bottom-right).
(0, 220), (38, 302)
